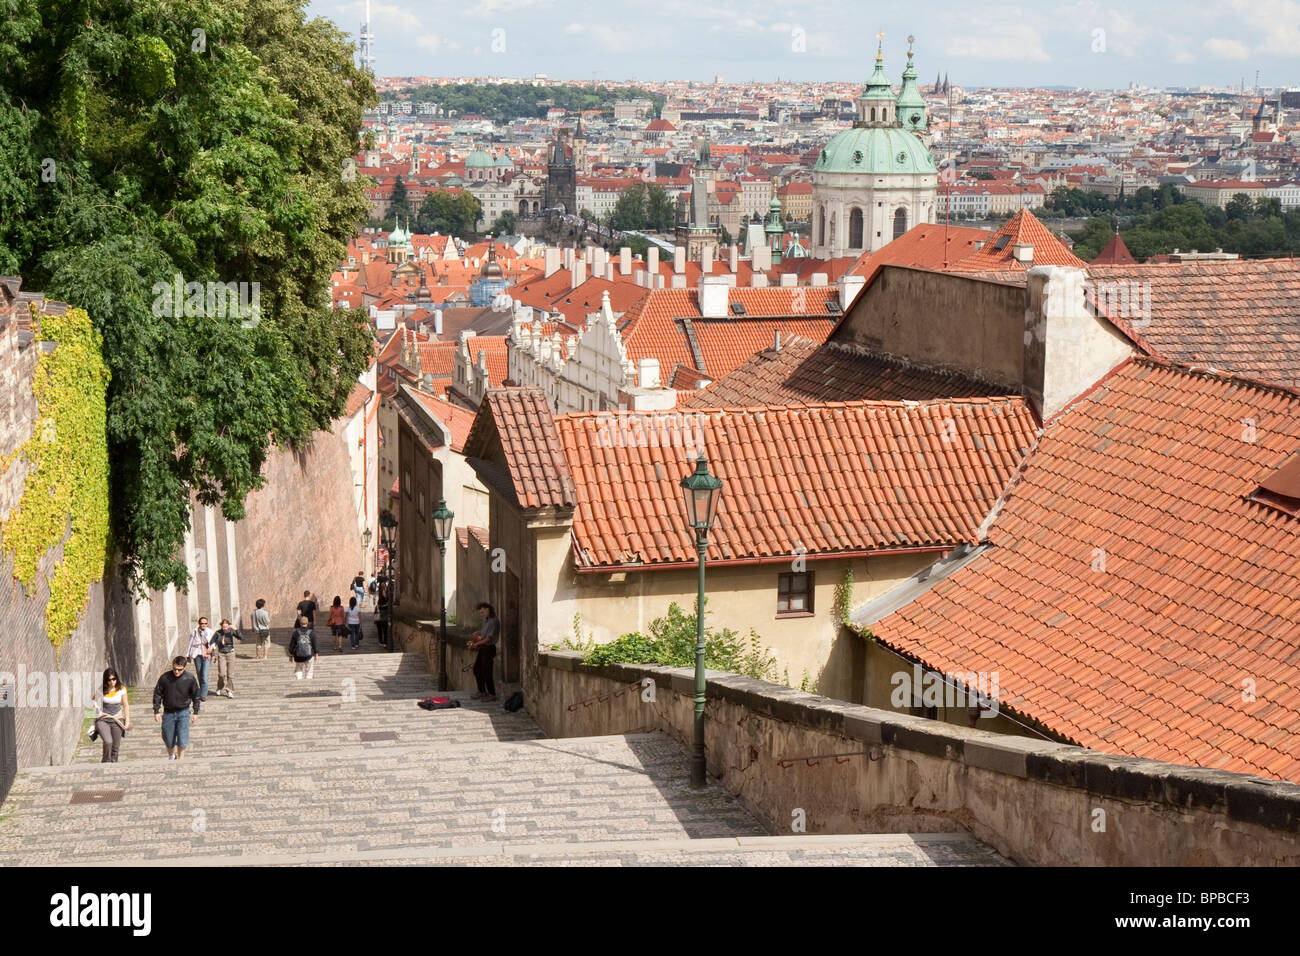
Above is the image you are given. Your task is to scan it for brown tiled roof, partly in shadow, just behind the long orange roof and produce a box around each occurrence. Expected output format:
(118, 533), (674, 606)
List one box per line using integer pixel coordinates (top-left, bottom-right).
(685, 337), (1008, 408)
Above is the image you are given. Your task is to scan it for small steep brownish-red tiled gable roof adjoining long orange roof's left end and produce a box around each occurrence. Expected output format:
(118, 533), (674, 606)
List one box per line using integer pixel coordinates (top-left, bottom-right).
(465, 388), (576, 509)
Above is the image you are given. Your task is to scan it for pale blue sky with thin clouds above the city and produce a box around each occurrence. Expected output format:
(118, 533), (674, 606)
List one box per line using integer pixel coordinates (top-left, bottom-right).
(308, 0), (1300, 88)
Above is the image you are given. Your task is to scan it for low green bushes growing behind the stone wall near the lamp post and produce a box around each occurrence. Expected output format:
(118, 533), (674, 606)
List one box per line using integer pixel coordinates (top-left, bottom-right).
(585, 602), (776, 680)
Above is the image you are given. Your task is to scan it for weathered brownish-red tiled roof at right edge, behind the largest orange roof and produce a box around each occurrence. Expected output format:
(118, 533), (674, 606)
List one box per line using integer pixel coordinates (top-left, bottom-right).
(1088, 259), (1300, 388)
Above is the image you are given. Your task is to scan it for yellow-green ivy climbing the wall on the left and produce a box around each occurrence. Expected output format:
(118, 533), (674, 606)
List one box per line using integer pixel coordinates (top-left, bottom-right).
(0, 308), (109, 648)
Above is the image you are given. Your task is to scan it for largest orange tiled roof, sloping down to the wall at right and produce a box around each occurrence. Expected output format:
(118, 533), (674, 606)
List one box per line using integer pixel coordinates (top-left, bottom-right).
(872, 359), (1300, 780)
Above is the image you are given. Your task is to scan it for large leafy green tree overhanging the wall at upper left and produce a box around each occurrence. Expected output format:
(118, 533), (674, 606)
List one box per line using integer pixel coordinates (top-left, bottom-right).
(0, 0), (376, 588)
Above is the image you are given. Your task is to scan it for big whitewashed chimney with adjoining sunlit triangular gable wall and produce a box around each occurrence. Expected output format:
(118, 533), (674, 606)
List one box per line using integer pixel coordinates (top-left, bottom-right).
(1022, 265), (1134, 420)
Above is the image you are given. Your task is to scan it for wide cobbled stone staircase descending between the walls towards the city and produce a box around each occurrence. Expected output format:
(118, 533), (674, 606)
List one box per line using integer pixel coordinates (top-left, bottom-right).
(0, 622), (1005, 865)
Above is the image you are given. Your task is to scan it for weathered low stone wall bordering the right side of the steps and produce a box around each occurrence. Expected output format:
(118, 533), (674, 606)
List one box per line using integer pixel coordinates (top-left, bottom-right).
(525, 652), (1300, 866)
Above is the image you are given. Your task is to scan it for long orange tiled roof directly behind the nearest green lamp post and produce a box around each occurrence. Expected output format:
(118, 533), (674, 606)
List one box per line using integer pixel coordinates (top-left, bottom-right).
(555, 398), (1035, 568)
